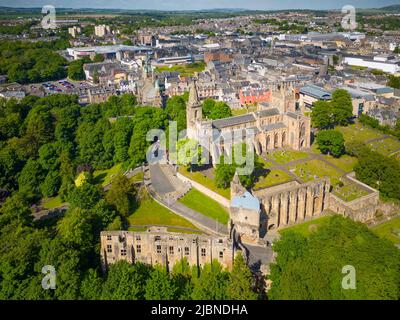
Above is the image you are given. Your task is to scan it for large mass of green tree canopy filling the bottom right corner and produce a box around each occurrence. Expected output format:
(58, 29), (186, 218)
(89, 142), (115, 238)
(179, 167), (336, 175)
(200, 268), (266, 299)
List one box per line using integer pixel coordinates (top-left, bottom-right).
(268, 215), (400, 300)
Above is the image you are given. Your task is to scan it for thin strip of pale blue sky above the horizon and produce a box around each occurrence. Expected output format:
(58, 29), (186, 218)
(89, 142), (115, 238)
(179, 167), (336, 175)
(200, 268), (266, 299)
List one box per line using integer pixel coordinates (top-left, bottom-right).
(0, 0), (400, 10)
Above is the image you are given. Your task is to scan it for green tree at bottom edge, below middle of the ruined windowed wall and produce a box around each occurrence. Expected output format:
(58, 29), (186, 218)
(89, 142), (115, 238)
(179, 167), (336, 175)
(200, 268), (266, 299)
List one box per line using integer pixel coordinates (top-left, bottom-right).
(145, 266), (177, 300)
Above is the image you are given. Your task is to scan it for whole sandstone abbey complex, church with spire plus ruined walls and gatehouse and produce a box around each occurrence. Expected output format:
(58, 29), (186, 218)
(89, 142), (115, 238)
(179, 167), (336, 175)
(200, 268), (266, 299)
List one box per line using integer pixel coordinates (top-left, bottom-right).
(101, 82), (379, 270)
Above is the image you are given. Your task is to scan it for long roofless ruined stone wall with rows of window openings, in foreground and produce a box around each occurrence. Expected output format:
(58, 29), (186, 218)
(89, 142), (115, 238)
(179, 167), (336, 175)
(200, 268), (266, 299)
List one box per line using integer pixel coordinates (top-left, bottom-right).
(100, 227), (234, 270)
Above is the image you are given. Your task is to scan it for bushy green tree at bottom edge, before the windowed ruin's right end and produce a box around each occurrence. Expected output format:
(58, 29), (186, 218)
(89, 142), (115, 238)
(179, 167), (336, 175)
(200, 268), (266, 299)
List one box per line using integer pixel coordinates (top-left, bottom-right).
(192, 260), (229, 300)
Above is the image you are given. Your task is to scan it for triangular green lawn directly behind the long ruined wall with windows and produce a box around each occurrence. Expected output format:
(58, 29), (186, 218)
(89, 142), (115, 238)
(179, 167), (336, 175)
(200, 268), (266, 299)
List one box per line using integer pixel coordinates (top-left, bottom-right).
(128, 195), (198, 230)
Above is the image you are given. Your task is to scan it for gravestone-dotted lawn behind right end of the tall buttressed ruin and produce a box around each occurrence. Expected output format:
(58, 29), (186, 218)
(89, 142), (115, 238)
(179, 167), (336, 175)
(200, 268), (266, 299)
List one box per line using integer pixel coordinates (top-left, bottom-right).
(289, 159), (342, 185)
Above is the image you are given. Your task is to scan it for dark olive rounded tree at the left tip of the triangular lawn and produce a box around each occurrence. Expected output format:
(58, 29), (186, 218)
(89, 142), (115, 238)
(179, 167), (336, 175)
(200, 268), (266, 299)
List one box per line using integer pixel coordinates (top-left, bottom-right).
(106, 175), (136, 216)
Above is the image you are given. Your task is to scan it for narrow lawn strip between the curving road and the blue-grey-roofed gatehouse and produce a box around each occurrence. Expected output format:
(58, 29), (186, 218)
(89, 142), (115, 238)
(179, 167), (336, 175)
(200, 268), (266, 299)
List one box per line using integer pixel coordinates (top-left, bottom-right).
(179, 188), (229, 224)
